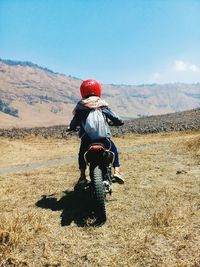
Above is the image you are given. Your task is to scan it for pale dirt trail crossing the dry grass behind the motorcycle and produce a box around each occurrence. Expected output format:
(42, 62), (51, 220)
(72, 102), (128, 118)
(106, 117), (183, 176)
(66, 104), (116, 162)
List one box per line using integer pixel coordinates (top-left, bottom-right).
(0, 142), (164, 175)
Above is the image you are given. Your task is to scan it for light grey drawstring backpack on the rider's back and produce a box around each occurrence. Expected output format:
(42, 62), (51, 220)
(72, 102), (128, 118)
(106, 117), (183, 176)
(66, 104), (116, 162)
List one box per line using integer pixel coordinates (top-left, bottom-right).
(82, 109), (110, 140)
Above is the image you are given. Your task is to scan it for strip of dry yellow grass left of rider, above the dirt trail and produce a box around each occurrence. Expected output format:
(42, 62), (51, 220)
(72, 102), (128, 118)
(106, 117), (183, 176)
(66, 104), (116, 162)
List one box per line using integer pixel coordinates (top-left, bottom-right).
(0, 137), (79, 167)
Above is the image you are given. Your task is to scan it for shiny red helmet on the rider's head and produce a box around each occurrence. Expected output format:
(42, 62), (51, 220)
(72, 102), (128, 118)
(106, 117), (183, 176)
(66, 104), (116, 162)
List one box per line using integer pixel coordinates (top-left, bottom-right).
(80, 80), (101, 98)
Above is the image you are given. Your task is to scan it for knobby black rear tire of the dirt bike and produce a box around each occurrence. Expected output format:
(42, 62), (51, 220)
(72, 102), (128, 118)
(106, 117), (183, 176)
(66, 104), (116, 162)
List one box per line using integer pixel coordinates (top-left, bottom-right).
(91, 166), (106, 223)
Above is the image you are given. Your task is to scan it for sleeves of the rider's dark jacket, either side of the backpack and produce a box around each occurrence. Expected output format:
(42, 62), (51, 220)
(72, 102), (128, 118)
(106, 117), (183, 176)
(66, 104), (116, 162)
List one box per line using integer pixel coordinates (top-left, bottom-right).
(69, 105), (124, 137)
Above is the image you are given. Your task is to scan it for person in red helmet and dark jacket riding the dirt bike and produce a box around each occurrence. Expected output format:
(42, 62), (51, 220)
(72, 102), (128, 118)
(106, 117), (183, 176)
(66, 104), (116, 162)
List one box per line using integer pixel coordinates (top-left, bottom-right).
(69, 80), (124, 184)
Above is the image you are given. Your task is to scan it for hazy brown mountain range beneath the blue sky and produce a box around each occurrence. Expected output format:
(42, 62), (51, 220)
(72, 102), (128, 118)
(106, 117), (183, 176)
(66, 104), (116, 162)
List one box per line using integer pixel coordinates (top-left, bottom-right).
(0, 60), (200, 128)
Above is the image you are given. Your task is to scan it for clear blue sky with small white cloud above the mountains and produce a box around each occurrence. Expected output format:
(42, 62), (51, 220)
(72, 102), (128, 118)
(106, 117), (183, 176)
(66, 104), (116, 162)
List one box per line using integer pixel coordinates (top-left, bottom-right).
(0, 0), (200, 84)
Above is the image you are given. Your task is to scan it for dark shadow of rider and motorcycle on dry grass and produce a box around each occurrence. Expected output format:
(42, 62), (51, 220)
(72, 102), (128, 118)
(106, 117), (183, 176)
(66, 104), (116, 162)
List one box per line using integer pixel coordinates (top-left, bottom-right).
(36, 182), (104, 227)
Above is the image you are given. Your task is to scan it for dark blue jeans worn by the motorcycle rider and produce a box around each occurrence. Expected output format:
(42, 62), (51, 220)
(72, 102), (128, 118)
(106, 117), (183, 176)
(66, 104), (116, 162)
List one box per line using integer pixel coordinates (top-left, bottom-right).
(78, 136), (120, 169)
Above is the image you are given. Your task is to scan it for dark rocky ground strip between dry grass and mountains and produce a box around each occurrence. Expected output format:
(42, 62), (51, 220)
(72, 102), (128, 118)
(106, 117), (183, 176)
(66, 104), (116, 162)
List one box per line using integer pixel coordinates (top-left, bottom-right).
(0, 108), (200, 138)
